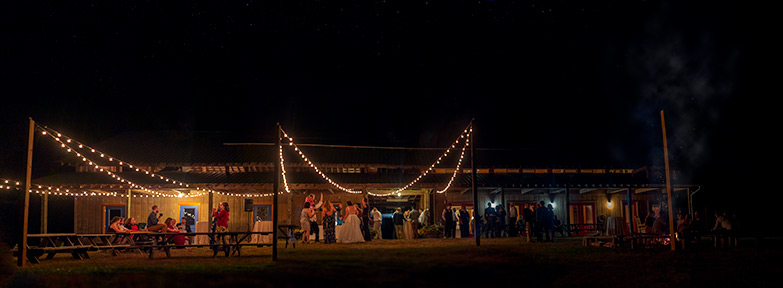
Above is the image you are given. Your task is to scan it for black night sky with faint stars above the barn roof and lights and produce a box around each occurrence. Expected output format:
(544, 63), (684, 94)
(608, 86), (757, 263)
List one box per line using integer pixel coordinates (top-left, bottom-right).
(0, 0), (767, 212)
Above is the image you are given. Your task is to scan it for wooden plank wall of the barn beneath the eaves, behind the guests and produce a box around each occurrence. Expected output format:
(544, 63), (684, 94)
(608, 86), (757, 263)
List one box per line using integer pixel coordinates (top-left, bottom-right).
(69, 189), (662, 233)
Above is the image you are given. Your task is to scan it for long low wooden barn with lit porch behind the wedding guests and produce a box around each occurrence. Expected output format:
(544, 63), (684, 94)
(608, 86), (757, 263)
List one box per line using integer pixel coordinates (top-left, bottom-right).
(31, 132), (696, 233)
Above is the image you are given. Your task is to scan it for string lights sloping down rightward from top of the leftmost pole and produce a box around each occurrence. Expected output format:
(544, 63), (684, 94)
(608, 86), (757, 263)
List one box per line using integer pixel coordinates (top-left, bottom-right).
(36, 124), (280, 197)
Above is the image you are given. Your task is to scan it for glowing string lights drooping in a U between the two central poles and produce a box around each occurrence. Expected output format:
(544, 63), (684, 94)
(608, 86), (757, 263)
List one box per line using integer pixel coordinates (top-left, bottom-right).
(280, 123), (473, 197)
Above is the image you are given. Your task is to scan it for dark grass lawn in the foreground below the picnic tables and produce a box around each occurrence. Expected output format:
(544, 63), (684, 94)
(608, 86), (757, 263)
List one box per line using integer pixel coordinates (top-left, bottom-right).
(0, 238), (783, 288)
